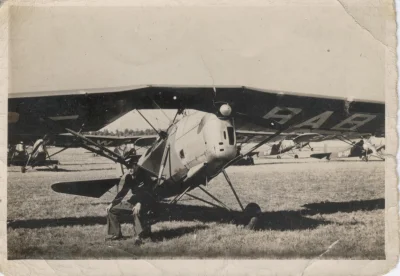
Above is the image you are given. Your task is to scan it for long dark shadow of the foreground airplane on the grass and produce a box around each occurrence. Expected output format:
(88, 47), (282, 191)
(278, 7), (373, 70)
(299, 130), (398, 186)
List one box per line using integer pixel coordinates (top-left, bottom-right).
(7, 198), (385, 240)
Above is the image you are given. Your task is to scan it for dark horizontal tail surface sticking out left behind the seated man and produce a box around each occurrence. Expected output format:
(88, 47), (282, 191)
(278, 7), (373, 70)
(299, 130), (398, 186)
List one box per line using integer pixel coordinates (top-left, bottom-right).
(51, 178), (120, 198)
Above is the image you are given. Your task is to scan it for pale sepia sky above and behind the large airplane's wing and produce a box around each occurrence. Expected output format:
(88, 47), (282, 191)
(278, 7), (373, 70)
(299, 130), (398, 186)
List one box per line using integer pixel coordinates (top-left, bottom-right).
(10, 0), (393, 129)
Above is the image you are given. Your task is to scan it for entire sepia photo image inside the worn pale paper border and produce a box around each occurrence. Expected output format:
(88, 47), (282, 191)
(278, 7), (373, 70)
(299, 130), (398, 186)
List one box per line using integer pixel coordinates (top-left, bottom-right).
(3, 1), (397, 268)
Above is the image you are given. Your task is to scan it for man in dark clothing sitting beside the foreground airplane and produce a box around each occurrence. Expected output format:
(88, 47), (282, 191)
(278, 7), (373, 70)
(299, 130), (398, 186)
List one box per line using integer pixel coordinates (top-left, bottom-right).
(107, 164), (157, 244)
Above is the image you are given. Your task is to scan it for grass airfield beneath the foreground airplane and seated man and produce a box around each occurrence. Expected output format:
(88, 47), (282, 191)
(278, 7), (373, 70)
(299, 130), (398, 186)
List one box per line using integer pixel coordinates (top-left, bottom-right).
(8, 150), (385, 259)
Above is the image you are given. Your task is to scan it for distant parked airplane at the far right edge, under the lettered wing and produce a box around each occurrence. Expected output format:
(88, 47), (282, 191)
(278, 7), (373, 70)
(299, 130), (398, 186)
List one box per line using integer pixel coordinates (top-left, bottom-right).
(310, 136), (385, 162)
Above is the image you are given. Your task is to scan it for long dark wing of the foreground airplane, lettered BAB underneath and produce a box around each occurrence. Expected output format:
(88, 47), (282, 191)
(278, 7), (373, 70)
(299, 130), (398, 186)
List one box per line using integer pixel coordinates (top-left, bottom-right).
(8, 86), (385, 143)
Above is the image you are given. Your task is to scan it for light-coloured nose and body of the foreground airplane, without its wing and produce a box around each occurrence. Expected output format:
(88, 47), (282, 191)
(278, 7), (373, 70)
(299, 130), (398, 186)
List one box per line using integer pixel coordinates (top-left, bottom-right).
(138, 112), (237, 197)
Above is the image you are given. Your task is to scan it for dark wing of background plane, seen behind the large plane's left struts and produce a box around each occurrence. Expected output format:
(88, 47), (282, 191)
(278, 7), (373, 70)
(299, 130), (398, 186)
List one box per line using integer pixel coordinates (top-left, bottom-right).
(52, 133), (158, 148)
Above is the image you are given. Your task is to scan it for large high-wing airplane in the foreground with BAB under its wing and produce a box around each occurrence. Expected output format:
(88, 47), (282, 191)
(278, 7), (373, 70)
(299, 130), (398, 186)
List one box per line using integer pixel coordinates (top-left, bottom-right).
(8, 86), (385, 229)
